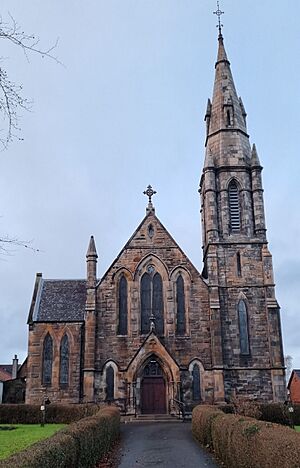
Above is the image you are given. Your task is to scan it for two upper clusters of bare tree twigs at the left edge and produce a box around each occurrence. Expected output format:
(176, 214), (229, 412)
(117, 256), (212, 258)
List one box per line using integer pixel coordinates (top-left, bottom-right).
(0, 11), (60, 149)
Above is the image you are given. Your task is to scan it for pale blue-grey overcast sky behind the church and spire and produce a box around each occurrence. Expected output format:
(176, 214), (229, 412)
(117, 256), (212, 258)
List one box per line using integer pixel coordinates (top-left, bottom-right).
(0, 0), (300, 368)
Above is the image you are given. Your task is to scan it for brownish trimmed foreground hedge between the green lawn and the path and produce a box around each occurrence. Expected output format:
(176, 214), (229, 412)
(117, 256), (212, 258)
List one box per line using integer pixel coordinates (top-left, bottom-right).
(0, 406), (120, 468)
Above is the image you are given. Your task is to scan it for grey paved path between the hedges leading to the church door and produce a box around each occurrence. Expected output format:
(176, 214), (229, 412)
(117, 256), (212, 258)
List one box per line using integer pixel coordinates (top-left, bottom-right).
(118, 422), (218, 468)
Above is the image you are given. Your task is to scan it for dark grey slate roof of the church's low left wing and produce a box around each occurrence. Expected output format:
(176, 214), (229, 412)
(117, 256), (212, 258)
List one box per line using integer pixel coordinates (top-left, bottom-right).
(32, 279), (86, 322)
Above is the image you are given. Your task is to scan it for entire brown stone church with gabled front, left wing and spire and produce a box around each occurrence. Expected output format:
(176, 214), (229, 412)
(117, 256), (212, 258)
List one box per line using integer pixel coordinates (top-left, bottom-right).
(26, 29), (285, 414)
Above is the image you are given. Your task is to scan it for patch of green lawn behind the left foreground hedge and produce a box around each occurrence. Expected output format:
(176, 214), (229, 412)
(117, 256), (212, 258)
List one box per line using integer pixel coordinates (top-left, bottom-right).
(0, 424), (65, 460)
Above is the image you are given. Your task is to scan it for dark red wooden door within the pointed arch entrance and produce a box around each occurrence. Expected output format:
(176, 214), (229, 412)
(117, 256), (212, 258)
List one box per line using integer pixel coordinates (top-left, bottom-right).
(141, 356), (167, 414)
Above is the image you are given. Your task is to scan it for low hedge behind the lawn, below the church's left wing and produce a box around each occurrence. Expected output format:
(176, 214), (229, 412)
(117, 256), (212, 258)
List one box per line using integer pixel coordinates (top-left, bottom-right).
(0, 404), (100, 424)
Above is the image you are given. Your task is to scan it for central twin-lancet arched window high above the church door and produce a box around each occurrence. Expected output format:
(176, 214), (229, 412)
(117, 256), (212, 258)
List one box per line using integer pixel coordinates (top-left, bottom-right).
(141, 268), (164, 335)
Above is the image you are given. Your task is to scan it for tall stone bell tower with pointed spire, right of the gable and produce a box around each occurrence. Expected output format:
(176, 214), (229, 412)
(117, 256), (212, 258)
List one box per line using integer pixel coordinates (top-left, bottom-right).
(199, 15), (285, 401)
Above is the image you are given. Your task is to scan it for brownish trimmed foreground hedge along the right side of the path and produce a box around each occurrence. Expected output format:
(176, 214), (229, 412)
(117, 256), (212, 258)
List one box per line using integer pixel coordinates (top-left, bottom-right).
(192, 406), (300, 468)
